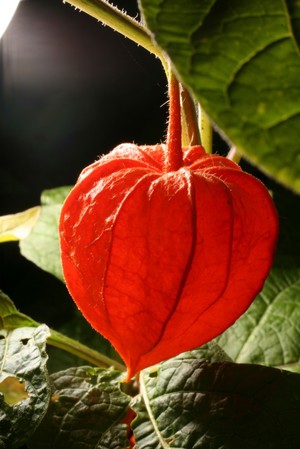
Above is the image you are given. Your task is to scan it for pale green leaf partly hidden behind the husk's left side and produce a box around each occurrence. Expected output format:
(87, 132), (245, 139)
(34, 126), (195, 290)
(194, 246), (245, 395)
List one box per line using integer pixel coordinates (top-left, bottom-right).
(20, 187), (71, 281)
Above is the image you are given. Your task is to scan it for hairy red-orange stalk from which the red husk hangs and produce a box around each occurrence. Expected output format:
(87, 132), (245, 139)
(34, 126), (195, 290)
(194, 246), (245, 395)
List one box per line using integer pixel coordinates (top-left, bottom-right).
(166, 70), (183, 172)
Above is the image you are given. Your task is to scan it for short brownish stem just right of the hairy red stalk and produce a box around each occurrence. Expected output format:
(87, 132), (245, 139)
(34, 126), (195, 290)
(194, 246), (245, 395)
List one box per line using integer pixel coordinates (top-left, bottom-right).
(181, 86), (200, 147)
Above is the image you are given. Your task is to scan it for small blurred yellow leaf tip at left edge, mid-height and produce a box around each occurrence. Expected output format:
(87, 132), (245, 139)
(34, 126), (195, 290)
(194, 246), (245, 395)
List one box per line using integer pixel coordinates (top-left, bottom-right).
(0, 207), (40, 243)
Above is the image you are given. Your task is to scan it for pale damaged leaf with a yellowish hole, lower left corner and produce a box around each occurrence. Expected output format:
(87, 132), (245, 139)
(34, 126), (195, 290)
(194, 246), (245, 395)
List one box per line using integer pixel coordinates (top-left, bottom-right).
(0, 325), (50, 449)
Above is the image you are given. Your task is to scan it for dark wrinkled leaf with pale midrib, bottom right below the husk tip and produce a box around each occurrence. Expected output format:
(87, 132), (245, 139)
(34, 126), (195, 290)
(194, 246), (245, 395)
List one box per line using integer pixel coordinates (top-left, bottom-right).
(132, 353), (300, 449)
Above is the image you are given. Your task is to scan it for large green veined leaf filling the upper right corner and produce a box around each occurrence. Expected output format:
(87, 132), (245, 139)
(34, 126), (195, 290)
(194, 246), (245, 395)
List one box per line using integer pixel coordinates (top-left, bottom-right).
(140, 0), (300, 192)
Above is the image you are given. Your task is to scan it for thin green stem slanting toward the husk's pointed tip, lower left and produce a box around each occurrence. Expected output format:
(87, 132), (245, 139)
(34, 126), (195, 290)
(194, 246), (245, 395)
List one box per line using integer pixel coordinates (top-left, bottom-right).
(47, 329), (126, 371)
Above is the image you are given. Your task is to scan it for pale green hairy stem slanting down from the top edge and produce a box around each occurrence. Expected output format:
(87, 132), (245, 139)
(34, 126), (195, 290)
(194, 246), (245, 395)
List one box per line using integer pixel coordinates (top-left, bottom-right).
(63, 0), (168, 73)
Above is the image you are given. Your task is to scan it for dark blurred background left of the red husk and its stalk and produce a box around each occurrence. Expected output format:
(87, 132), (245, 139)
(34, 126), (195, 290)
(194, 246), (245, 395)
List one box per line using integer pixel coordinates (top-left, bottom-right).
(0, 0), (167, 327)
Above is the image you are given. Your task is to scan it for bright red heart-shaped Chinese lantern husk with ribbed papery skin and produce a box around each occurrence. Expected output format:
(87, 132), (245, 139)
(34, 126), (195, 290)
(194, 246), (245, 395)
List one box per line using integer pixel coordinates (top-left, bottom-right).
(60, 75), (278, 380)
